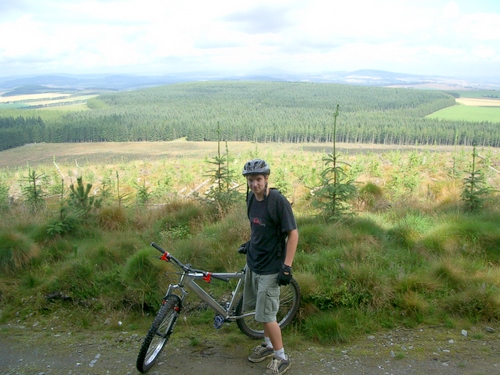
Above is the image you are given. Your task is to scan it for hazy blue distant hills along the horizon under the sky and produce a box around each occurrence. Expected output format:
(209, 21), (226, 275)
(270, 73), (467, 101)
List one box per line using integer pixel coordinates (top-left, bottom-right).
(0, 69), (500, 92)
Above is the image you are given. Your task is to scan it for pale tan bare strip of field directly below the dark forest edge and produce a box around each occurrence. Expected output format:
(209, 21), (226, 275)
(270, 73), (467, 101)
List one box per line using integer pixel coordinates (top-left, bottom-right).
(0, 138), (471, 168)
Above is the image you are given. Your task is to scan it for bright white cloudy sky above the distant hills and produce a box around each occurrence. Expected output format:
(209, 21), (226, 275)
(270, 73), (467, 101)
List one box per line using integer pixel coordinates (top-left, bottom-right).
(0, 0), (500, 77)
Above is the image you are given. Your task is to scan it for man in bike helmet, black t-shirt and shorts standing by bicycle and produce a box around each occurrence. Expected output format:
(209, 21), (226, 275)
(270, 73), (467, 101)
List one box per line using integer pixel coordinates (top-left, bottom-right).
(242, 159), (299, 374)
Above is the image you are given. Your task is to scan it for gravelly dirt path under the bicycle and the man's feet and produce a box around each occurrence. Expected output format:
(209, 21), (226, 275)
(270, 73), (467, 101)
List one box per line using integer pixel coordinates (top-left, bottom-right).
(0, 325), (500, 375)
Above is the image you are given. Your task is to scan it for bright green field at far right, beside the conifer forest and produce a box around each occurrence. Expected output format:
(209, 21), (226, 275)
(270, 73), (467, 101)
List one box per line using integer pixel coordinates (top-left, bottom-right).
(426, 104), (500, 123)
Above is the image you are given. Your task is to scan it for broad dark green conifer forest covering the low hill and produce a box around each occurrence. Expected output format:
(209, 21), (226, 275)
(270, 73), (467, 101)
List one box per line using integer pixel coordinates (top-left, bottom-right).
(0, 81), (500, 150)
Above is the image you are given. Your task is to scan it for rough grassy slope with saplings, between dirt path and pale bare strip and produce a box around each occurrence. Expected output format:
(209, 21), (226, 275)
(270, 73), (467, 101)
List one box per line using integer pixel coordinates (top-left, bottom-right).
(0, 141), (500, 343)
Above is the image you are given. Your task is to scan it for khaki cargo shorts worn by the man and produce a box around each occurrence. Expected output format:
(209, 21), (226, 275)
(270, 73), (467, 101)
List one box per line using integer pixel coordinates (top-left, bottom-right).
(243, 268), (280, 323)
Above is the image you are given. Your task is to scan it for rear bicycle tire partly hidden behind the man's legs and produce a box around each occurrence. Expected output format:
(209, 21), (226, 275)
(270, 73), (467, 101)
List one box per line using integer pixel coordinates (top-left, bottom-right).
(236, 279), (301, 339)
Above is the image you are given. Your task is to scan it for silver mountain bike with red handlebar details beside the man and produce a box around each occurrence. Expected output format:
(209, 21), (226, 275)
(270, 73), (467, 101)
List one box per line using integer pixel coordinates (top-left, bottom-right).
(136, 242), (301, 373)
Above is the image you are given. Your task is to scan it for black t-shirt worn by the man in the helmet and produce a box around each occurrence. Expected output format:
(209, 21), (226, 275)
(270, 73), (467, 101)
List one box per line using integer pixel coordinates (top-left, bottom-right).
(247, 192), (297, 275)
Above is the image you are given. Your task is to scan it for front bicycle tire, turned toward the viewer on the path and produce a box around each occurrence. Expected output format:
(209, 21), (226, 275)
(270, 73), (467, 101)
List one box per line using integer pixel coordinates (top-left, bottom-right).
(136, 294), (181, 373)
